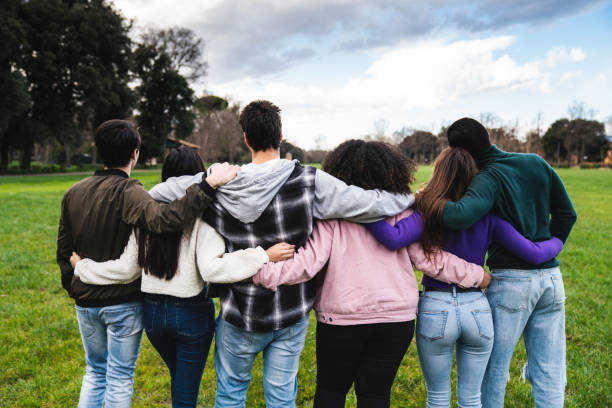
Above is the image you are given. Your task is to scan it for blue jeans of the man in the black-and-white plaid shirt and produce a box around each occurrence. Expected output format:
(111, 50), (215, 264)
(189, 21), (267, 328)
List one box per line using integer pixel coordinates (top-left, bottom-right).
(215, 316), (308, 408)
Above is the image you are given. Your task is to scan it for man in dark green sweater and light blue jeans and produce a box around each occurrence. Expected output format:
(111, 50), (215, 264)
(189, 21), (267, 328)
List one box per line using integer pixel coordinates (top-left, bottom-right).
(443, 118), (577, 408)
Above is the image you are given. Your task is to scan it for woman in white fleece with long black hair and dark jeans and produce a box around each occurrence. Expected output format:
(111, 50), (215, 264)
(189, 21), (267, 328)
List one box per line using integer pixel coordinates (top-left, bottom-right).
(71, 148), (293, 407)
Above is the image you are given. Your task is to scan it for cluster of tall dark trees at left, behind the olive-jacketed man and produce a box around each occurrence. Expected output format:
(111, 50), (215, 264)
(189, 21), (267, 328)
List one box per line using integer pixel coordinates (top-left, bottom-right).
(0, 0), (207, 171)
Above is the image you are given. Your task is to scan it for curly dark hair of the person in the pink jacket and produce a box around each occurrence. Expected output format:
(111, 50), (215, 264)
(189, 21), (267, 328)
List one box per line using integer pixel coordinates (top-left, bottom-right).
(323, 139), (416, 193)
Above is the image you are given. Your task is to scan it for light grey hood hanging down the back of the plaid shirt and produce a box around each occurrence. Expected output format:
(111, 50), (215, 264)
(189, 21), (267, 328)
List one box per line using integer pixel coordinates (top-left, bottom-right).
(216, 159), (298, 224)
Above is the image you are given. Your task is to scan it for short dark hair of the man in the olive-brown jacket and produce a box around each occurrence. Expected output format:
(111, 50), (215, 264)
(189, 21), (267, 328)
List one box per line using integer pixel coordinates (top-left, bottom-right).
(94, 119), (140, 167)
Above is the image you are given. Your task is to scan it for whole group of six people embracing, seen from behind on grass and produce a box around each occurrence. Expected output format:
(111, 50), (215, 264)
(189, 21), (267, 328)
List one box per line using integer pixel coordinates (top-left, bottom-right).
(57, 100), (576, 408)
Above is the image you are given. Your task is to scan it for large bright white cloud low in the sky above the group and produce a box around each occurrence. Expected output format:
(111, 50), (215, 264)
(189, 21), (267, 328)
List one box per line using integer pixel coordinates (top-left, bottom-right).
(212, 36), (550, 147)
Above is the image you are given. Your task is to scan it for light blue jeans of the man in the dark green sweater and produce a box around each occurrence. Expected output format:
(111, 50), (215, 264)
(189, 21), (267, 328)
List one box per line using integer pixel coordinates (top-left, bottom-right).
(482, 268), (565, 408)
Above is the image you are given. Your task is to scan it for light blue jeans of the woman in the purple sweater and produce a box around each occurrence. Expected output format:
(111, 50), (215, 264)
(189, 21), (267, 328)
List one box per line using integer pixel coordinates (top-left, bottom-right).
(416, 291), (493, 408)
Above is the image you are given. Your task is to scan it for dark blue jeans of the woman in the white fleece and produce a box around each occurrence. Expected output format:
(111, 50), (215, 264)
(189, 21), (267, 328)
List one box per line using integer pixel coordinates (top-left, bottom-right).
(143, 290), (215, 408)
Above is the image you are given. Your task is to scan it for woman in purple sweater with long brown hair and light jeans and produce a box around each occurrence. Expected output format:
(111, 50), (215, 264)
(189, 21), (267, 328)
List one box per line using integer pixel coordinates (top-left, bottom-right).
(367, 148), (563, 408)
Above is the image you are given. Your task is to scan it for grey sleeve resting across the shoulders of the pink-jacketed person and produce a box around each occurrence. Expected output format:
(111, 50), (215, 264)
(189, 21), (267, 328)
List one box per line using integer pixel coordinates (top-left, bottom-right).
(313, 170), (414, 223)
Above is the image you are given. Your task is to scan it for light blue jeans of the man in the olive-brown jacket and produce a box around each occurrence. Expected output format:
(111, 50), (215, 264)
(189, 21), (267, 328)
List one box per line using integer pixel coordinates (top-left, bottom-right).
(76, 302), (142, 408)
